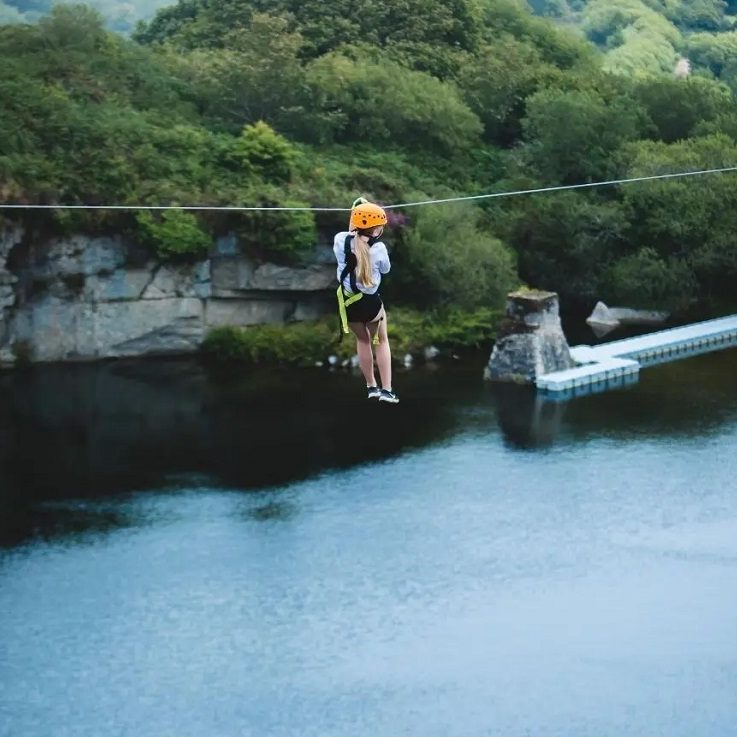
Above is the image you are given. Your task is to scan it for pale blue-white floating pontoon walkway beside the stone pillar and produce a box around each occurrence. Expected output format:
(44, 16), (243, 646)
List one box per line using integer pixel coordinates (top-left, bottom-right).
(536, 315), (737, 398)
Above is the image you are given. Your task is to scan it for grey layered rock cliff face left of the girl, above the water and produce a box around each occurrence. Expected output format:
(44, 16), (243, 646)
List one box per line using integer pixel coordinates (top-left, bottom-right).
(0, 228), (335, 365)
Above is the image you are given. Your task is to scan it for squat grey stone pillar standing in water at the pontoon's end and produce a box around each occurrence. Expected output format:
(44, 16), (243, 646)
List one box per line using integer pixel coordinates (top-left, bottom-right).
(485, 289), (576, 384)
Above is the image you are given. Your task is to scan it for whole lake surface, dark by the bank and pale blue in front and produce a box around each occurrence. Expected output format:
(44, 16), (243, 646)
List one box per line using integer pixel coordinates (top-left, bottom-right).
(0, 349), (737, 737)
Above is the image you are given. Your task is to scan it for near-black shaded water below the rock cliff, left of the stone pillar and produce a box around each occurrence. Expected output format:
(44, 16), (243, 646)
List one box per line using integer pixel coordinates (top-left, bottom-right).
(0, 360), (483, 544)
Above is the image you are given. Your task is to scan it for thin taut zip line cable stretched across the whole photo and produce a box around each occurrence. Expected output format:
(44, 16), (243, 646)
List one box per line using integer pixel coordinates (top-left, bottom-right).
(0, 166), (737, 212)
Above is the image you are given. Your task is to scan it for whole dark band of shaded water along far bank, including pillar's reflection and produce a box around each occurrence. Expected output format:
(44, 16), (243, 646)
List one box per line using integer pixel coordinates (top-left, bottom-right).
(0, 349), (737, 545)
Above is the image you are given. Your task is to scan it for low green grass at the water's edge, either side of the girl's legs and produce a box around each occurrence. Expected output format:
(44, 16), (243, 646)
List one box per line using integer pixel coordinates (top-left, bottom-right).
(202, 308), (503, 366)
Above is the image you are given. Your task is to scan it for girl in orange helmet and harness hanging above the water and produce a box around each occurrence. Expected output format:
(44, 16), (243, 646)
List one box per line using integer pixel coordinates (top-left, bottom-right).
(333, 197), (399, 404)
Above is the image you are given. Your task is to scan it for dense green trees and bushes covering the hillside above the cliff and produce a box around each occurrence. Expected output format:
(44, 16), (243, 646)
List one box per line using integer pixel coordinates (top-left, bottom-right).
(0, 0), (737, 320)
